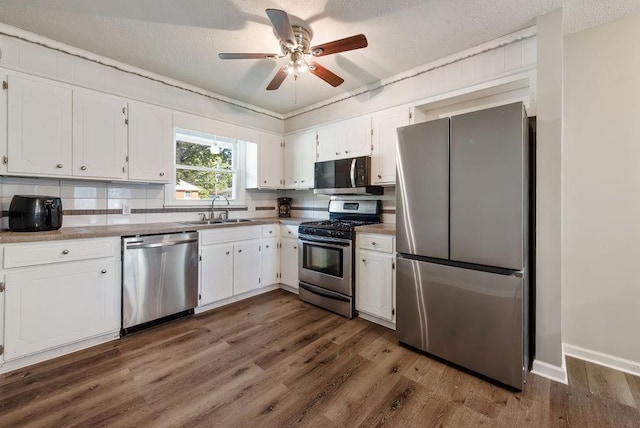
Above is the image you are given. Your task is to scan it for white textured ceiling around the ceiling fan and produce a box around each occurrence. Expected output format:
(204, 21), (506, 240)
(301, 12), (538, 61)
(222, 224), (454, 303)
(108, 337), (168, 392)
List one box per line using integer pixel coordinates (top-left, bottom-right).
(0, 0), (640, 114)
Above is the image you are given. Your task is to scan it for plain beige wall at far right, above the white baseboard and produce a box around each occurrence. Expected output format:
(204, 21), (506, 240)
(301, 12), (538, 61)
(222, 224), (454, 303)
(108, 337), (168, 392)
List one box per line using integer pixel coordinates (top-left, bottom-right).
(562, 15), (640, 365)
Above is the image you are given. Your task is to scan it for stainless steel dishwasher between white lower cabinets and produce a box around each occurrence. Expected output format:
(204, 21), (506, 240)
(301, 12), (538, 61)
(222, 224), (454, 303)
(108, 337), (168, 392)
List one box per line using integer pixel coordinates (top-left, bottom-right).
(122, 232), (198, 334)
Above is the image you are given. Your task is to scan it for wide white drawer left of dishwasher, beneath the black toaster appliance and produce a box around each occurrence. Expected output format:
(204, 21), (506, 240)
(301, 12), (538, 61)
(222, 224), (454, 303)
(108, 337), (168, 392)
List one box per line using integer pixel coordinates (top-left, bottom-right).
(3, 238), (120, 268)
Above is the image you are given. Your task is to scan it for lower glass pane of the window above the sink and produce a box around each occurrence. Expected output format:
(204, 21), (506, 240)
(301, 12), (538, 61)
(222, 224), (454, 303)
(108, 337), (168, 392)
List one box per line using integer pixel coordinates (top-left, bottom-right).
(176, 168), (235, 199)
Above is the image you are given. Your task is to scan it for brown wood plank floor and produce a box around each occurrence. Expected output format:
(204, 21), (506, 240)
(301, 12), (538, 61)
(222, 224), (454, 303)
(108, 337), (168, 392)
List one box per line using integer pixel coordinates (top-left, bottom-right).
(0, 290), (640, 428)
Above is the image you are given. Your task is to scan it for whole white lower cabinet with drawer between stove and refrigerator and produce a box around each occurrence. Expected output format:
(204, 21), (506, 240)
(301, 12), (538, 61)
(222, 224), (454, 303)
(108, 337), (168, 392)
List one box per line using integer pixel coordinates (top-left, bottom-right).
(356, 234), (395, 324)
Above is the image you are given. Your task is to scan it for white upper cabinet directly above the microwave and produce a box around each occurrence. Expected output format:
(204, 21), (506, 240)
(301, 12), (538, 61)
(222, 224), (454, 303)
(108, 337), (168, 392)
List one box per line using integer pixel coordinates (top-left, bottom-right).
(318, 116), (371, 161)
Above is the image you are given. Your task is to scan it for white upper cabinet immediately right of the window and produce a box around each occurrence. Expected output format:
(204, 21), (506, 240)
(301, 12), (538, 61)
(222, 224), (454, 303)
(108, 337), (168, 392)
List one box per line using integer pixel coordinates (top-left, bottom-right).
(245, 133), (284, 189)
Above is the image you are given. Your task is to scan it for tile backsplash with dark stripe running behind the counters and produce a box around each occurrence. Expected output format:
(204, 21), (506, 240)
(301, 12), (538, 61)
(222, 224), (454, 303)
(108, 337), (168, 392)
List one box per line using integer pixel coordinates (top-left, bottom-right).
(0, 177), (395, 229)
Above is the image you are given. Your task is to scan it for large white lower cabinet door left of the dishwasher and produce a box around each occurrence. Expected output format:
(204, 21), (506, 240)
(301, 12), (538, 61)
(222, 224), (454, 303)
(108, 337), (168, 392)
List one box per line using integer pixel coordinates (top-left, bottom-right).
(5, 258), (120, 361)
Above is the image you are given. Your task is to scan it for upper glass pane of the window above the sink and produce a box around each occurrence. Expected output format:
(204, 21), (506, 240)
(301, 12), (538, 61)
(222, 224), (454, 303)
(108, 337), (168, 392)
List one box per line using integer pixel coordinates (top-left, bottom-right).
(176, 140), (233, 169)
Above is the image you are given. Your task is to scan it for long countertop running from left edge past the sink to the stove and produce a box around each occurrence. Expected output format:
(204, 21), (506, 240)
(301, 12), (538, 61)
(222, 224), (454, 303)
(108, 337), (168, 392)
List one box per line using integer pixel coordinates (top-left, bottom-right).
(0, 217), (314, 244)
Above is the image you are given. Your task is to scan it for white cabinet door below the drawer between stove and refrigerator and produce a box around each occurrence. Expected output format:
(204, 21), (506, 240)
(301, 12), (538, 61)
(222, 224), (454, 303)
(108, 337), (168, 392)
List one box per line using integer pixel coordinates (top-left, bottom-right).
(356, 250), (393, 321)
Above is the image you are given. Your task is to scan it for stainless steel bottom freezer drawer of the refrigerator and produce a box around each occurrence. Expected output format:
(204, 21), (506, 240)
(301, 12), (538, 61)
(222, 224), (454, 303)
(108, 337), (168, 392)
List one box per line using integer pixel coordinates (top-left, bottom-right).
(396, 258), (526, 389)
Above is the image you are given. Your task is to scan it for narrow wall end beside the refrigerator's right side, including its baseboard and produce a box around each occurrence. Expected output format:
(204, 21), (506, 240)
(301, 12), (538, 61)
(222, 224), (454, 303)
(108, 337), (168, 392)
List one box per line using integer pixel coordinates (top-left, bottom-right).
(533, 9), (565, 374)
